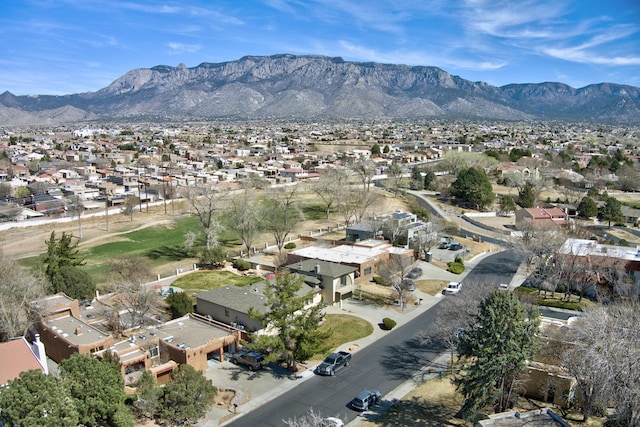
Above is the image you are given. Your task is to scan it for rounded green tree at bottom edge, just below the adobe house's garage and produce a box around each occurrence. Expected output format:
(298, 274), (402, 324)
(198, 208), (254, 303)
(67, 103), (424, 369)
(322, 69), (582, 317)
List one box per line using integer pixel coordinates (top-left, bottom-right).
(158, 364), (218, 425)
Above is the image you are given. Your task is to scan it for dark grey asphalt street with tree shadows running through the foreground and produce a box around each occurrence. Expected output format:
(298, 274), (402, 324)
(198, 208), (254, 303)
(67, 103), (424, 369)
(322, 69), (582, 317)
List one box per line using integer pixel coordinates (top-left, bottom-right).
(228, 251), (520, 427)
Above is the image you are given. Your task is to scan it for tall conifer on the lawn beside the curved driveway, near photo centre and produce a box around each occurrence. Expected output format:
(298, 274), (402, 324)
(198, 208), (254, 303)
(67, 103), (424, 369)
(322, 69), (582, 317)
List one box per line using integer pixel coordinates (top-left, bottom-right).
(249, 272), (330, 370)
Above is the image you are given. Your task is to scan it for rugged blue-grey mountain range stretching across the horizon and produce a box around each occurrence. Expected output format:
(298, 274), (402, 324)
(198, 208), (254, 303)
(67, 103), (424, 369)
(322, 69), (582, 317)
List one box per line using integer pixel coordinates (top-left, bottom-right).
(0, 54), (640, 125)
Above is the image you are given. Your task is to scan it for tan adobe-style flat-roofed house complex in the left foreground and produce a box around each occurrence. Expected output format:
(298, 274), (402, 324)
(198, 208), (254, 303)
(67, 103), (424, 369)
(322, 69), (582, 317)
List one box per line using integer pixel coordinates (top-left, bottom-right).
(33, 294), (241, 385)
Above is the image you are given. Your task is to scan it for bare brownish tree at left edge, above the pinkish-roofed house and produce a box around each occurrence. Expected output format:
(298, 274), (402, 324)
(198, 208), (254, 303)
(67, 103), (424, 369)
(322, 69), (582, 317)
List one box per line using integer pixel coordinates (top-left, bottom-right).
(0, 252), (46, 341)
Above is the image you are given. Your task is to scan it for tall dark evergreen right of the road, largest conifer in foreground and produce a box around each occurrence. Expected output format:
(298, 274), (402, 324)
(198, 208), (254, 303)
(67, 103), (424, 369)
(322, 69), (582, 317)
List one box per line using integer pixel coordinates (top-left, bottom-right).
(454, 291), (540, 418)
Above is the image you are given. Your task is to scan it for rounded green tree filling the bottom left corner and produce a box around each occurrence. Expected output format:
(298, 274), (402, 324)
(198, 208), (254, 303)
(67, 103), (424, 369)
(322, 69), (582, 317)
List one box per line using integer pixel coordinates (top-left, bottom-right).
(0, 370), (78, 427)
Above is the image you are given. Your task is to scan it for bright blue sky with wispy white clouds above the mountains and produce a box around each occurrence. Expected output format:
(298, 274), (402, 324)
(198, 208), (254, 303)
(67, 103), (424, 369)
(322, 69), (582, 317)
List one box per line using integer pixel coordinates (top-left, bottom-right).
(0, 0), (640, 95)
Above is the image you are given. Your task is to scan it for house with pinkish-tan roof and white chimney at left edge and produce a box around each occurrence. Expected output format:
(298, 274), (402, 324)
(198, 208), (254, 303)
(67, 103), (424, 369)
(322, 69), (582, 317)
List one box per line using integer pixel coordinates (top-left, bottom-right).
(0, 335), (49, 388)
